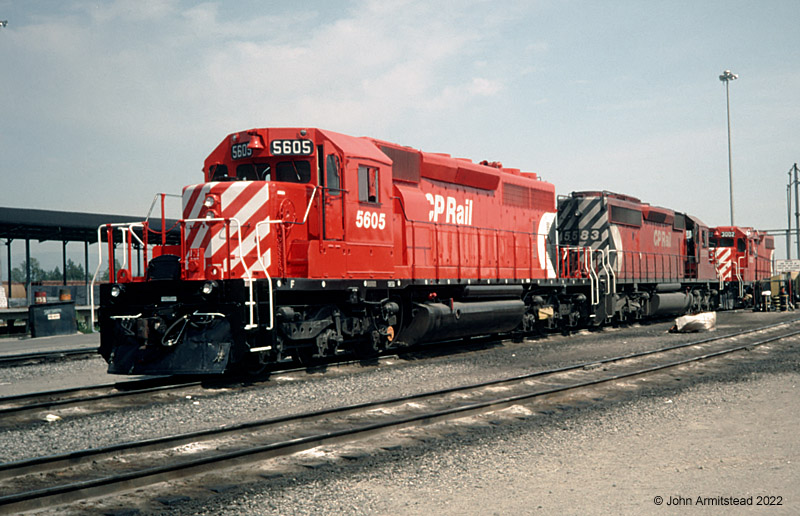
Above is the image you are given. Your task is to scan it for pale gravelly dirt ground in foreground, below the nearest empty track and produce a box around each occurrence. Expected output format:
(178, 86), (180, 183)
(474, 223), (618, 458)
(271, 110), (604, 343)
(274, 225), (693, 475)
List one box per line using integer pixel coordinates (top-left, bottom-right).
(159, 320), (800, 515)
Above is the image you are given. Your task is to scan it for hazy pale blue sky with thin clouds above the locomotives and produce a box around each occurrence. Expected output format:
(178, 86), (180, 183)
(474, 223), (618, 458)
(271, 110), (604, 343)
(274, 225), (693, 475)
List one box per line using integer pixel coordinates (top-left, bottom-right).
(0, 0), (800, 277)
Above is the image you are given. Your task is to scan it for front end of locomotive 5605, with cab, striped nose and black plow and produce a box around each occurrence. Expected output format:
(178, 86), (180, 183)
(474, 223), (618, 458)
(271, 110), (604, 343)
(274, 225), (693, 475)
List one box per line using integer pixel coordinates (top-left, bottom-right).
(100, 129), (396, 374)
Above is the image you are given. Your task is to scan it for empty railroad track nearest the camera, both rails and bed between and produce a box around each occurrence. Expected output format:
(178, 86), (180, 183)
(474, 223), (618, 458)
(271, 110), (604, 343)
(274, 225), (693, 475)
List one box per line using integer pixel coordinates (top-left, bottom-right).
(0, 321), (800, 514)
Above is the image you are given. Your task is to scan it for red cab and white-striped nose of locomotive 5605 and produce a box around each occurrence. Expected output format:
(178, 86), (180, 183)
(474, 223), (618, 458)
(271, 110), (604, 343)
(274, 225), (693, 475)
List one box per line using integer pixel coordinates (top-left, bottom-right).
(184, 129), (400, 279)
